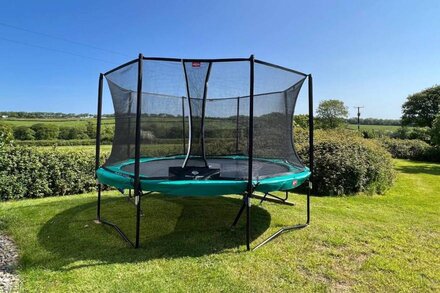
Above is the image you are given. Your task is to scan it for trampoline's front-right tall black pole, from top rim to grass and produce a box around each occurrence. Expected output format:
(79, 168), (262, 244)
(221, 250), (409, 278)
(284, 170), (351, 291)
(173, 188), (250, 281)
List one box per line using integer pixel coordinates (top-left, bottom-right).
(244, 55), (255, 250)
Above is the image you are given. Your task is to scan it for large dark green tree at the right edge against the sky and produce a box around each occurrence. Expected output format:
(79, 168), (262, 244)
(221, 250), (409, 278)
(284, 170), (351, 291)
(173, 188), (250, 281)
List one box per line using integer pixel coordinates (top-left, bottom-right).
(402, 85), (440, 128)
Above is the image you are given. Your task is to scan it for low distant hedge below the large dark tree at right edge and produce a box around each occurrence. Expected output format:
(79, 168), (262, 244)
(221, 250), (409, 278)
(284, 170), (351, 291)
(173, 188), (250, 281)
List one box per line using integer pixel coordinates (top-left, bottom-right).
(379, 139), (440, 162)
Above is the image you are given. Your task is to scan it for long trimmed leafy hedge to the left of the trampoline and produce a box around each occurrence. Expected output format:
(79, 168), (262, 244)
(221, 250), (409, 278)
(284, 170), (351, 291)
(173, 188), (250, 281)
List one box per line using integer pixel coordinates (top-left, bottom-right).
(0, 146), (106, 200)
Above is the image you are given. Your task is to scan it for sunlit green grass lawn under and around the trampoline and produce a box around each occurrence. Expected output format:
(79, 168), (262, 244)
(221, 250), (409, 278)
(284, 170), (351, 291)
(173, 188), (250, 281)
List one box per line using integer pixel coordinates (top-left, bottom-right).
(0, 160), (440, 292)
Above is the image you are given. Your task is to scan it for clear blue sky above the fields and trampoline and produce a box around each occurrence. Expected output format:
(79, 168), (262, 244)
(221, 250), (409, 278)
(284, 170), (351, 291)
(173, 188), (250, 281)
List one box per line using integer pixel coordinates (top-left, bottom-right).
(0, 0), (440, 119)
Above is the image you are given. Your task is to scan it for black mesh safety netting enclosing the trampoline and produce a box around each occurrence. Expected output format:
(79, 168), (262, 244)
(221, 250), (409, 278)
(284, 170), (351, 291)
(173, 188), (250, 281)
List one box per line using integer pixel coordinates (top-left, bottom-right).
(105, 59), (306, 179)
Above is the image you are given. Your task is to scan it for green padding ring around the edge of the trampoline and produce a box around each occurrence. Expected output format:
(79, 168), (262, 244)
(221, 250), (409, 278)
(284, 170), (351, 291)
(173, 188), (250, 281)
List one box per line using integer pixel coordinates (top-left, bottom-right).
(96, 156), (310, 196)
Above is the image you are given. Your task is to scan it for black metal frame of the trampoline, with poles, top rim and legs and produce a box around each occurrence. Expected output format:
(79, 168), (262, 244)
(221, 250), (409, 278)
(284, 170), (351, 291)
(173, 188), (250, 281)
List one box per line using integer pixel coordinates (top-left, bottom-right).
(95, 54), (314, 251)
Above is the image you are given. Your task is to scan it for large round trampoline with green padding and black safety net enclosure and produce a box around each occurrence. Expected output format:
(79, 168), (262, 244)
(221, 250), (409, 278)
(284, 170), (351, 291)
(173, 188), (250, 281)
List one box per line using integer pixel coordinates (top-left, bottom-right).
(96, 55), (313, 250)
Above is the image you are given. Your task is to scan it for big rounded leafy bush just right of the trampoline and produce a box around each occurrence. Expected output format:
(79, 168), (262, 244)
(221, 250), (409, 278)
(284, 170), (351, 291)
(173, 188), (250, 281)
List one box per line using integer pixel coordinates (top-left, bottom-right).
(295, 130), (395, 195)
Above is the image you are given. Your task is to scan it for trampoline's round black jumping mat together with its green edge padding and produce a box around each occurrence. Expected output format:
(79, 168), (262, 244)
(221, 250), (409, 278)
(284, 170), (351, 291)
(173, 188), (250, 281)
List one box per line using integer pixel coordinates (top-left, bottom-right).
(97, 156), (310, 196)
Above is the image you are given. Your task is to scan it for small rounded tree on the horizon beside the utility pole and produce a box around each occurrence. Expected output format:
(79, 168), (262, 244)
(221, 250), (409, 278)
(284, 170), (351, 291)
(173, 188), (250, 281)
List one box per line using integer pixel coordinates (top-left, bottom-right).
(316, 100), (348, 128)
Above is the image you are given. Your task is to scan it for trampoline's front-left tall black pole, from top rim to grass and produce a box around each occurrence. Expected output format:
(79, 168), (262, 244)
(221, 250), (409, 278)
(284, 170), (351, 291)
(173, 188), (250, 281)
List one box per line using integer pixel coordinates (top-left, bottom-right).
(134, 54), (144, 248)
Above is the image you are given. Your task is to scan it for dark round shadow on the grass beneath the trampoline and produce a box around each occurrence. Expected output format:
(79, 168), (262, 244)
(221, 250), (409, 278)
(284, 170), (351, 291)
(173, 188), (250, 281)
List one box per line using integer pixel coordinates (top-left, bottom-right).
(38, 195), (271, 270)
